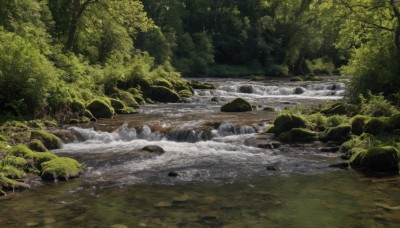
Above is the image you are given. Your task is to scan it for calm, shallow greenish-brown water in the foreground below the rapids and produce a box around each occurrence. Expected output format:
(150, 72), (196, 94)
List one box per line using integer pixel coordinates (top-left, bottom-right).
(0, 171), (400, 227)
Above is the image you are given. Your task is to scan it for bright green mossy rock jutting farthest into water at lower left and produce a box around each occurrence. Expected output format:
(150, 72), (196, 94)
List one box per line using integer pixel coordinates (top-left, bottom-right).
(41, 158), (84, 181)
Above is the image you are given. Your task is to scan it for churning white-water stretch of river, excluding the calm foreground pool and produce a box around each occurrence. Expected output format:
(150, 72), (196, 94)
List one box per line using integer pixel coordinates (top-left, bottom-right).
(55, 80), (344, 184)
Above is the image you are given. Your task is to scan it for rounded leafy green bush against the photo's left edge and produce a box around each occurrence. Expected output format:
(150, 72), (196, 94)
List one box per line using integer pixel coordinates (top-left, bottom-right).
(0, 27), (55, 114)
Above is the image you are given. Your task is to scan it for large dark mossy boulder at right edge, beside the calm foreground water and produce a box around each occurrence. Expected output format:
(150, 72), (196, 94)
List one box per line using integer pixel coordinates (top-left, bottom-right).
(350, 146), (400, 172)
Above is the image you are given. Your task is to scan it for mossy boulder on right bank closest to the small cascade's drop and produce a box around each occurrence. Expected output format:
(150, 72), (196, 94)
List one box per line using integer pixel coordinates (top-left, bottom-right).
(270, 113), (309, 136)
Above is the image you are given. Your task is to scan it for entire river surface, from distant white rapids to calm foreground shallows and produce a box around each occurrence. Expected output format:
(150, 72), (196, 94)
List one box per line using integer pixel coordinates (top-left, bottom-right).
(0, 79), (400, 227)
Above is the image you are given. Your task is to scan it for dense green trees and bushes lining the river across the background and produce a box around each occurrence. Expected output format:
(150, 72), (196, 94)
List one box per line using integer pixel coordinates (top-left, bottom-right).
(0, 0), (400, 121)
